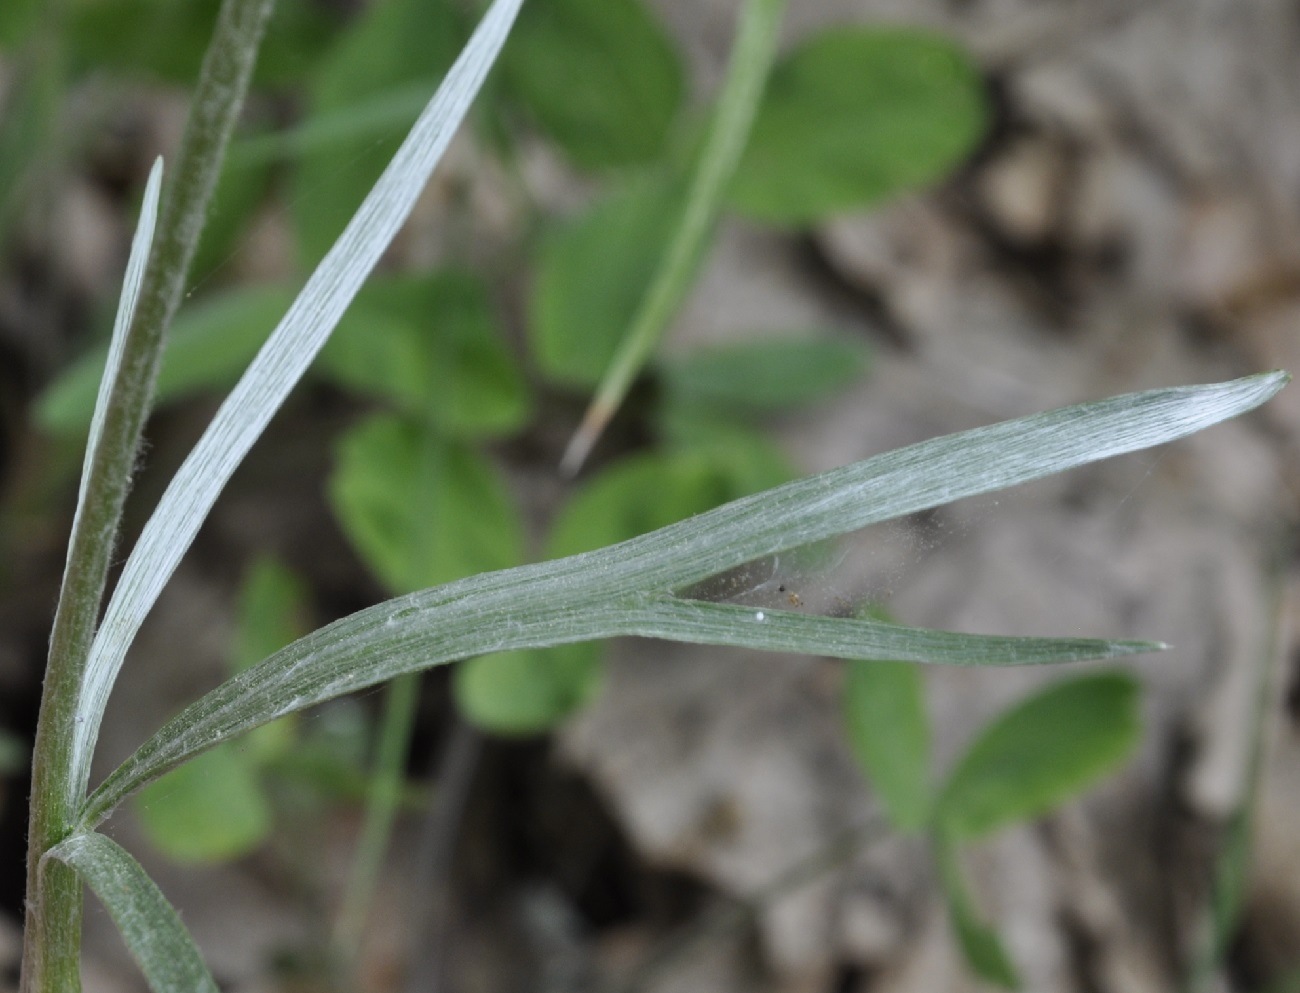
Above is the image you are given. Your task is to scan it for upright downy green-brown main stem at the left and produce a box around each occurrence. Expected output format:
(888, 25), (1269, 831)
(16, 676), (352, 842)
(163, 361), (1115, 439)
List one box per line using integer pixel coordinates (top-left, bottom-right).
(21, 0), (274, 993)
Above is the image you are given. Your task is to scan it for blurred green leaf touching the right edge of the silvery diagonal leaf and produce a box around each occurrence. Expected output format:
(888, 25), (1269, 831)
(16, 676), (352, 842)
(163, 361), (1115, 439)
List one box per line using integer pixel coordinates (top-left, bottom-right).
(317, 272), (532, 438)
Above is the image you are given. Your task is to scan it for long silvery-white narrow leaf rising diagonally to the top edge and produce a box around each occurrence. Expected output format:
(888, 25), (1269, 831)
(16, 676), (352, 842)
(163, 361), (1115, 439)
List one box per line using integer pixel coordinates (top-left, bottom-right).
(70, 0), (521, 790)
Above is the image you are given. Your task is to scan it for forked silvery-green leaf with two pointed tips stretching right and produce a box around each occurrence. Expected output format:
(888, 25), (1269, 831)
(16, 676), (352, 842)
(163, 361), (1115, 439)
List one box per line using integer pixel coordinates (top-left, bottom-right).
(83, 373), (1288, 824)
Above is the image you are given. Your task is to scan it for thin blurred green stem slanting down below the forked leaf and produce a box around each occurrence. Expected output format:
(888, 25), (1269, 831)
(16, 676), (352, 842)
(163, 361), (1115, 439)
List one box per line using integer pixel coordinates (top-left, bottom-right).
(334, 675), (420, 962)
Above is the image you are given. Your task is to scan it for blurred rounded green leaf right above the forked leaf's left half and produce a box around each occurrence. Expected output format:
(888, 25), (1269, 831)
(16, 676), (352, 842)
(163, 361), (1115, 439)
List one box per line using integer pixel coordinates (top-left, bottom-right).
(329, 415), (524, 591)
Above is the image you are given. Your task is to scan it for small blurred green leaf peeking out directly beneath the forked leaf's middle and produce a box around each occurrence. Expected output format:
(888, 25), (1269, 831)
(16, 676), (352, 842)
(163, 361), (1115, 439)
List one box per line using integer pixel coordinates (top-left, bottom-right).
(452, 642), (602, 734)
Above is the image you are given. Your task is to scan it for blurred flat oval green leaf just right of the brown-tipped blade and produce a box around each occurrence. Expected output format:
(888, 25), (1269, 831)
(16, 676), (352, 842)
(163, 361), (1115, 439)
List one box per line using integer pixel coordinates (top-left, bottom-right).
(658, 335), (867, 413)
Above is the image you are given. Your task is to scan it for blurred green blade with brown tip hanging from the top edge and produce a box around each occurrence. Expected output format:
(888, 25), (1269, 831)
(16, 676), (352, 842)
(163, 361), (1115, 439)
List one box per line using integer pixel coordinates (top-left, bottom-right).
(560, 0), (785, 476)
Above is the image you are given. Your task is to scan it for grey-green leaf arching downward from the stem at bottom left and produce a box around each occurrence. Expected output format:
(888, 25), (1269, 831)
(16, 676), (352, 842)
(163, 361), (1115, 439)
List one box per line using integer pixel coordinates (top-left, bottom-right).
(46, 834), (218, 993)
